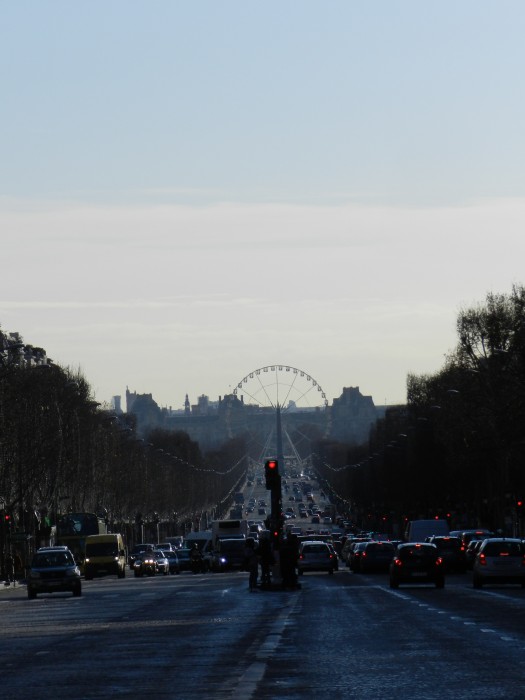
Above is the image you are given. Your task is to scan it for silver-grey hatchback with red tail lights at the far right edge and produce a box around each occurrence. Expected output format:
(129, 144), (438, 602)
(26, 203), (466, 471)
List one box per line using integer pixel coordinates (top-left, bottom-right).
(472, 537), (525, 588)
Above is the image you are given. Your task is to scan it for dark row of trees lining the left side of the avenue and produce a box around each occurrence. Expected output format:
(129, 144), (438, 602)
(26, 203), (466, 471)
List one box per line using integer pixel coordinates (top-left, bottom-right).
(0, 331), (247, 548)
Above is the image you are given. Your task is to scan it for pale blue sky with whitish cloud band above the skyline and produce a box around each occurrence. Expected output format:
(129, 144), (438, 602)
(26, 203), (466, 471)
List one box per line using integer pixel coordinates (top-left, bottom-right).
(0, 0), (525, 409)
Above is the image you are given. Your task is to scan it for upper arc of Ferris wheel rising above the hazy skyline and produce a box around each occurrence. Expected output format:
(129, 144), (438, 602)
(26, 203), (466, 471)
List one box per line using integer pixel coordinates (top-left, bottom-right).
(233, 365), (328, 413)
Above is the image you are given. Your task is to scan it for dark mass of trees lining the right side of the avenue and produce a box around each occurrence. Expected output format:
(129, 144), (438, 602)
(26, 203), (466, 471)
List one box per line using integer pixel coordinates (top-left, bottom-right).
(316, 285), (525, 535)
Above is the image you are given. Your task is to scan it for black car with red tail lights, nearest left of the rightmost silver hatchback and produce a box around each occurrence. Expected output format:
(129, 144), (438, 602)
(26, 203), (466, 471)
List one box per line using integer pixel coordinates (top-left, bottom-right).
(389, 542), (445, 588)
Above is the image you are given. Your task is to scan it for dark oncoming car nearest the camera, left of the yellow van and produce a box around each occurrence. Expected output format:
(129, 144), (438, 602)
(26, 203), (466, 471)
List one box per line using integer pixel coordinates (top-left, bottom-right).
(27, 547), (82, 598)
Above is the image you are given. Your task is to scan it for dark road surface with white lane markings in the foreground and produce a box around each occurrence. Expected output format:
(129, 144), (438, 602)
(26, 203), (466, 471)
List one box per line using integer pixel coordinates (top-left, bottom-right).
(0, 569), (525, 700)
